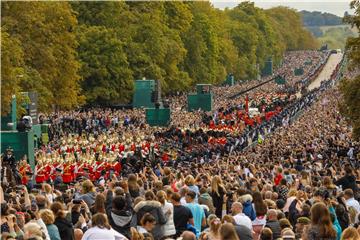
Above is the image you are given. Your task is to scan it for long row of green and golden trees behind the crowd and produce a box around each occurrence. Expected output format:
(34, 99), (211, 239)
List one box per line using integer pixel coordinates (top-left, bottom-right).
(1, 1), (318, 114)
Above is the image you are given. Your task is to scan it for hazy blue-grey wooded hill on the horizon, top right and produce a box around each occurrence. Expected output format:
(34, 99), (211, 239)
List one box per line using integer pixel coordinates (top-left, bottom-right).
(300, 10), (343, 27)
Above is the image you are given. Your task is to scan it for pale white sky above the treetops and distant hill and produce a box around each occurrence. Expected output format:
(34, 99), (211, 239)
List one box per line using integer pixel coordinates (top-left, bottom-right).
(210, 0), (353, 17)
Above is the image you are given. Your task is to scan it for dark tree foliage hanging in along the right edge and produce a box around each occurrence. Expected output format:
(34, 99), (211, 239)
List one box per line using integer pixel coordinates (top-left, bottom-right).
(340, 0), (360, 140)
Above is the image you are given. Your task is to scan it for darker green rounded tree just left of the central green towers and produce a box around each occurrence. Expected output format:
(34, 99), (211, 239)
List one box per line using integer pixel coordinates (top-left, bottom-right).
(78, 26), (133, 104)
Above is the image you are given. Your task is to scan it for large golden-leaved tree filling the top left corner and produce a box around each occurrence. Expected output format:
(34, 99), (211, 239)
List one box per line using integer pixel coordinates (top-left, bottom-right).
(1, 2), (83, 110)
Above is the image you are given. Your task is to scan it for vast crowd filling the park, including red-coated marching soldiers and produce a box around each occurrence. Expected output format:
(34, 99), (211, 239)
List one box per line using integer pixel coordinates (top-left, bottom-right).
(0, 51), (360, 240)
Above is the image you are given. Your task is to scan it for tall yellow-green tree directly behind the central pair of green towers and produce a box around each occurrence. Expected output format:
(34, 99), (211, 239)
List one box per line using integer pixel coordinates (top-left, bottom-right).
(127, 2), (190, 93)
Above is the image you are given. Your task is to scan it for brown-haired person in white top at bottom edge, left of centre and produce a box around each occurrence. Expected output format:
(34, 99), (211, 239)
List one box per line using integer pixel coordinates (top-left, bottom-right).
(81, 213), (128, 240)
